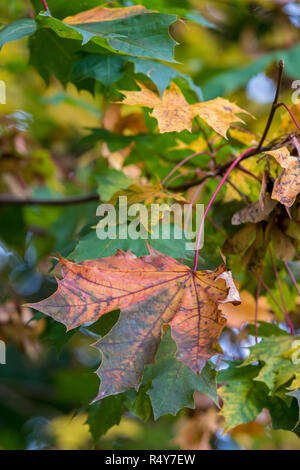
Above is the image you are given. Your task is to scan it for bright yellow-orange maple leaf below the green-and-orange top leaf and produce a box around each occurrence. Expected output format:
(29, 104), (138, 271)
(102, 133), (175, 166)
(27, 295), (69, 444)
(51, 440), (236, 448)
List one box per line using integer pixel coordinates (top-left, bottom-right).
(122, 82), (249, 139)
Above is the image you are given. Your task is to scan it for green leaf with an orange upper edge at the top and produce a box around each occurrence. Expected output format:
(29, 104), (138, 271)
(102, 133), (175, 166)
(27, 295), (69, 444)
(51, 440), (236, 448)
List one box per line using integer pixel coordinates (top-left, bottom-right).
(61, 5), (177, 62)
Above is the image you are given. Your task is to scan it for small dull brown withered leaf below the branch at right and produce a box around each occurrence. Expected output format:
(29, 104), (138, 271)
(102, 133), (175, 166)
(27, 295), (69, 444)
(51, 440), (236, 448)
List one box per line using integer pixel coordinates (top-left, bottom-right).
(231, 194), (277, 225)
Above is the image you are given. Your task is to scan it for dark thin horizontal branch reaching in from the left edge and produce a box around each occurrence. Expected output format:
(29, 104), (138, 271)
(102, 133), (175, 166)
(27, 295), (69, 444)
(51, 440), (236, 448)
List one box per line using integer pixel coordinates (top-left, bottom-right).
(0, 194), (100, 206)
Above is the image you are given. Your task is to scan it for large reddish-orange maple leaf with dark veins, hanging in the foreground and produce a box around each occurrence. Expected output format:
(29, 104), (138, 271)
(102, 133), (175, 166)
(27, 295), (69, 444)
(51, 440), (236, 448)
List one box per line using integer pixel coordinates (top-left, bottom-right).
(31, 248), (240, 398)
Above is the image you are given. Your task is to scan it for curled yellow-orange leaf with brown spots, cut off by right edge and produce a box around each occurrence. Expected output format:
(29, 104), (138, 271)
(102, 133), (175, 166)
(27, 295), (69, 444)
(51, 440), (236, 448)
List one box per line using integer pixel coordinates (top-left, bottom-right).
(268, 147), (300, 207)
